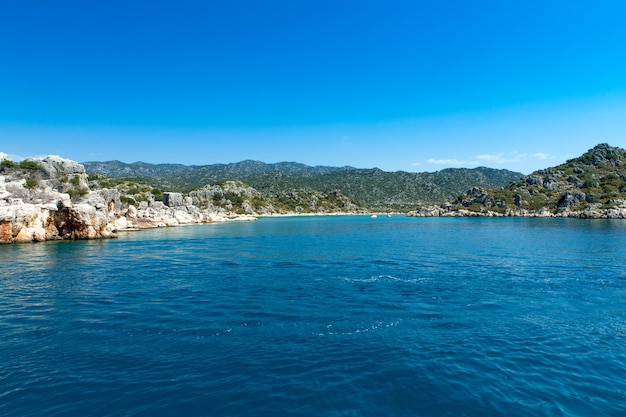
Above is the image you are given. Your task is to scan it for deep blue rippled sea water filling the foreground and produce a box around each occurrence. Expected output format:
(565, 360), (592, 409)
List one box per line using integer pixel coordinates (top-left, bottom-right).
(0, 216), (626, 416)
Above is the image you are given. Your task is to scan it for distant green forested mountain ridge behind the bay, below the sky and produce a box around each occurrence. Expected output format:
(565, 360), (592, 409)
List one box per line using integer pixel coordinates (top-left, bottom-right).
(83, 160), (522, 210)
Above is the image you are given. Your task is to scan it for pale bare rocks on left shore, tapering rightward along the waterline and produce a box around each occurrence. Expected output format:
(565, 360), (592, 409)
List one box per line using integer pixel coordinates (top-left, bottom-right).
(0, 154), (255, 243)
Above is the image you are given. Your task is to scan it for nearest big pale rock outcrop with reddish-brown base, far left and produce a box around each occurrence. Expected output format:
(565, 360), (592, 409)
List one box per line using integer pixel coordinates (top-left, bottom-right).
(0, 156), (126, 243)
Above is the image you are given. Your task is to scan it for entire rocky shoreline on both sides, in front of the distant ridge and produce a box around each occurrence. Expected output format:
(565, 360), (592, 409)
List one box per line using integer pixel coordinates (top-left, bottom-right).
(0, 144), (626, 243)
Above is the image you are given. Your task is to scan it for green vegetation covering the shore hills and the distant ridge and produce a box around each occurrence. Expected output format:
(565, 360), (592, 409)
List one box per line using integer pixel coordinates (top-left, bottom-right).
(7, 144), (626, 217)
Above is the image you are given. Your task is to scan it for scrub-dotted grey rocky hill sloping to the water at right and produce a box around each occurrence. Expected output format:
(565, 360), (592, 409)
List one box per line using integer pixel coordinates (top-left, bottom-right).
(409, 144), (626, 219)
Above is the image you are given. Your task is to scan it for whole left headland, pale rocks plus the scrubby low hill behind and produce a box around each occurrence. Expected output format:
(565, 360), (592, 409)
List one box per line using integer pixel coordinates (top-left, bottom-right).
(0, 153), (364, 243)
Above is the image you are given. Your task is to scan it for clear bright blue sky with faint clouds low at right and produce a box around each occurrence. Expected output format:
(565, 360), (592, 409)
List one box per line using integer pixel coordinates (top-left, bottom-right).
(0, 0), (626, 173)
